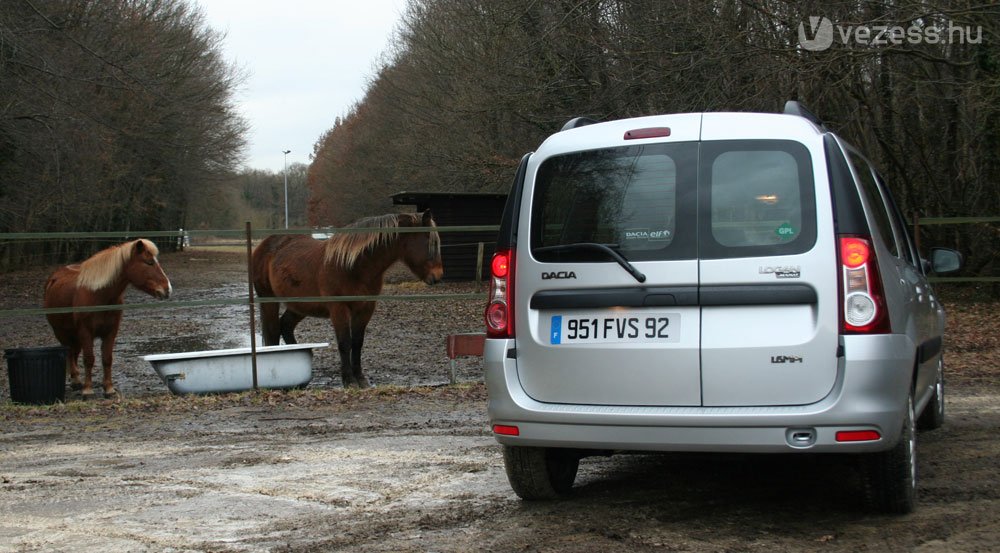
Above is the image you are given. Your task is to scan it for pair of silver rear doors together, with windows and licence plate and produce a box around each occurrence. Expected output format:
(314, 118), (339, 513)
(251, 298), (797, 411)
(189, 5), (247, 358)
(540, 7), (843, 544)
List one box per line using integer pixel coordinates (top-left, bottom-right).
(513, 114), (839, 406)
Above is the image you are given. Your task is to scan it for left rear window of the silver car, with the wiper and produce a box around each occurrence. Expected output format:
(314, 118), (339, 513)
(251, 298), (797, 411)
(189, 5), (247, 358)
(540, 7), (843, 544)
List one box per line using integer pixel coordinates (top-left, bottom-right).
(531, 143), (697, 261)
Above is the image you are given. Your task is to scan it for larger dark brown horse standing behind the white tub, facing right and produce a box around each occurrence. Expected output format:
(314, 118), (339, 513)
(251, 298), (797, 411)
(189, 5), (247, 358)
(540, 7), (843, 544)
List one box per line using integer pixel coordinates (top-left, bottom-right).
(251, 210), (444, 388)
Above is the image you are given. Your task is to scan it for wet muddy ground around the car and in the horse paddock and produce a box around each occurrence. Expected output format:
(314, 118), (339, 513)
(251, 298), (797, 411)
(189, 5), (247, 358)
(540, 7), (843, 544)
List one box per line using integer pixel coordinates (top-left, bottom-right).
(0, 251), (1000, 553)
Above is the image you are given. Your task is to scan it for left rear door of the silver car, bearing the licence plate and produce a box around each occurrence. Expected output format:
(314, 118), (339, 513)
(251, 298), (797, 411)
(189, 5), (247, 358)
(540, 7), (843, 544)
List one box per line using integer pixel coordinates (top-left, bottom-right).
(514, 117), (701, 405)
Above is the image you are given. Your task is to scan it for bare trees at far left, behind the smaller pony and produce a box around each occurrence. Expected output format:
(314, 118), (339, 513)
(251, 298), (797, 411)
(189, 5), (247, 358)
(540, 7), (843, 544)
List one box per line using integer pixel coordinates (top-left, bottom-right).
(0, 0), (246, 268)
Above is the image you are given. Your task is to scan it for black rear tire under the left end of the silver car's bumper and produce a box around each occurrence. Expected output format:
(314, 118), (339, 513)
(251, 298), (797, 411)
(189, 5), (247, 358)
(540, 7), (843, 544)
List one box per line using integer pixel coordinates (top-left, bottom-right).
(503, 445), (580, 501)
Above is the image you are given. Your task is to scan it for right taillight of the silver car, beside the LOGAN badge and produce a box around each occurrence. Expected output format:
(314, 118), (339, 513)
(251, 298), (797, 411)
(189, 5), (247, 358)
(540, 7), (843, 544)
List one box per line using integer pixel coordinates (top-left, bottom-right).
(840, 236), (892, 334)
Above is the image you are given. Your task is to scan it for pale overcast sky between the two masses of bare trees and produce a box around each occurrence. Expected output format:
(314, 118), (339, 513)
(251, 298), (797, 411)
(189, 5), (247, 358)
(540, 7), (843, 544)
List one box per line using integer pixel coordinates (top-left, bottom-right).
(194, 0), (406, 172)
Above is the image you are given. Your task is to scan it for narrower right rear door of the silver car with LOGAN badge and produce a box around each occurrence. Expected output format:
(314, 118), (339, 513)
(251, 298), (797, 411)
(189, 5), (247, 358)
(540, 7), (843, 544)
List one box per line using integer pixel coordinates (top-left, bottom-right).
(699, 128), (839, 406)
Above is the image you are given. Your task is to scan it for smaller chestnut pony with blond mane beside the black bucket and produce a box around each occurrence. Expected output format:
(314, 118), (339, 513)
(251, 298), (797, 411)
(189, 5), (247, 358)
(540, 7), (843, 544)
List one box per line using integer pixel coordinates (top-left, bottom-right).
(44, 239), (173, 399)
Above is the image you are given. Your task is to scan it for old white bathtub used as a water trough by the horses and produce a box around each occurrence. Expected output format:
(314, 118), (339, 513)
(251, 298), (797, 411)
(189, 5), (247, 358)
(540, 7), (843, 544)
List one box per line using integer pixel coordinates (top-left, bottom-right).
(143, 342), (330, 394)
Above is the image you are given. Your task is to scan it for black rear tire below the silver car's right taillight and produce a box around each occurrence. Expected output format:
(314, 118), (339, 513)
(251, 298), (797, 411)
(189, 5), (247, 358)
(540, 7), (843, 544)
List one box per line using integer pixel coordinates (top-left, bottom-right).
(863, 392), (917, 515)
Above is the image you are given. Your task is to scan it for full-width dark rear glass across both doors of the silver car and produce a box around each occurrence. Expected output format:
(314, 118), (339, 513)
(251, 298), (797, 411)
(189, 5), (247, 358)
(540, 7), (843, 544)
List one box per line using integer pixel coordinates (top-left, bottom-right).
(531, 140), (816, 262)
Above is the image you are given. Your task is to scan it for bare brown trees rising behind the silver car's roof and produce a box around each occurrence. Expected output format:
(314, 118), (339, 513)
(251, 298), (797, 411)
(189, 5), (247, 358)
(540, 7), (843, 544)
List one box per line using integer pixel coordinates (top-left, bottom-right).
(308, 0), (1000, 271)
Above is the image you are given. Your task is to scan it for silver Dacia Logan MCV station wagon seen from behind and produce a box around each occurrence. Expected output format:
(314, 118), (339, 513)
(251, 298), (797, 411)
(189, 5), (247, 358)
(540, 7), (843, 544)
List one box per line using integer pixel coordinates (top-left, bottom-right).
(484, 102), (961, 513)
